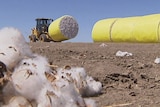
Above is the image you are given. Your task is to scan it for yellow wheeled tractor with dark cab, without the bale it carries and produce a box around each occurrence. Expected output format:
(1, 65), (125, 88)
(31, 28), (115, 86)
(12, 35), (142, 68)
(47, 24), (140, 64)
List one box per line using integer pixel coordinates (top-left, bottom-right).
(29, 18), (53, 42)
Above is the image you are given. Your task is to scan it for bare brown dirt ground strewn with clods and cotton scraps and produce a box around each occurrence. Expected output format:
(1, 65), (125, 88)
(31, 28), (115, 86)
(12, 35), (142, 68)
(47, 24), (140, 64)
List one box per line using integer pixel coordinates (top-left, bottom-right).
(30, 42), (160, 107)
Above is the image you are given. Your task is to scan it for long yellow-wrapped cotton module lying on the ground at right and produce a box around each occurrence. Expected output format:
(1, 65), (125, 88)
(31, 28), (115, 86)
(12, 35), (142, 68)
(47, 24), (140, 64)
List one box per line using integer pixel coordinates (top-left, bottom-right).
(92, 14), (160, 43)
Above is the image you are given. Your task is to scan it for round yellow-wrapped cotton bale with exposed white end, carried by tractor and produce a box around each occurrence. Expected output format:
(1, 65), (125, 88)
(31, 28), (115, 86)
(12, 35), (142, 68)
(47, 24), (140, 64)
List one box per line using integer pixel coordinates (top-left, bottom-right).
(48, 15), (79, 41)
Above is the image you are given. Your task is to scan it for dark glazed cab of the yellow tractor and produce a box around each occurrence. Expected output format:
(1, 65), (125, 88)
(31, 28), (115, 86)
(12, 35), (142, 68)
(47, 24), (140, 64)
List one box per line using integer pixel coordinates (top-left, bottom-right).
(36, 18), (53, 34)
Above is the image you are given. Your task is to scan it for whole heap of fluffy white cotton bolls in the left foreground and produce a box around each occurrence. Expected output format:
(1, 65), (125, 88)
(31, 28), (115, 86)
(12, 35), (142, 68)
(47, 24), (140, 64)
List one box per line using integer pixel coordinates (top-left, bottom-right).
(0, 28), (102, 107)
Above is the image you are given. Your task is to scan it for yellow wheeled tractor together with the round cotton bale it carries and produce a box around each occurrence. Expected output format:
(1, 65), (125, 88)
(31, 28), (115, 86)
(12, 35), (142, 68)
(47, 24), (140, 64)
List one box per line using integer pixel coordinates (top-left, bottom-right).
(29, 15), (79, 42)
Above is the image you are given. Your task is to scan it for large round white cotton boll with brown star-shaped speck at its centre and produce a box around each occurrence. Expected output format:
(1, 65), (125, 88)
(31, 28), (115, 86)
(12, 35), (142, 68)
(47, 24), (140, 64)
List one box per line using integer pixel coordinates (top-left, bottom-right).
(12, 55), (50, 100)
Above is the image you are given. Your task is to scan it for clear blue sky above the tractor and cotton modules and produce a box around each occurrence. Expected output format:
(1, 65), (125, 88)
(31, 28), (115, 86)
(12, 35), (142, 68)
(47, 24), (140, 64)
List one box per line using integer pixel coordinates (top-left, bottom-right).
(0, 0), (160, 42)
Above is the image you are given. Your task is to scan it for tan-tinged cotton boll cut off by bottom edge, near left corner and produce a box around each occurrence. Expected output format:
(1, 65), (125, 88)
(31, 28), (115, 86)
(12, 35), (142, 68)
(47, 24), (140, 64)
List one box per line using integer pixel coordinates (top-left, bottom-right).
(2, 96), (33, 107)
